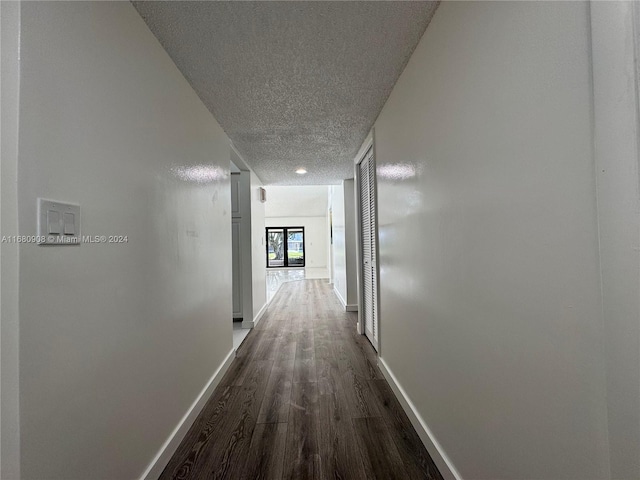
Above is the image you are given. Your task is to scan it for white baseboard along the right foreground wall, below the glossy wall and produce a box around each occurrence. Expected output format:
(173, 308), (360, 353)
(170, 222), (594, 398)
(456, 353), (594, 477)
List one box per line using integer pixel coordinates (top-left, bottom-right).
(378, 357), (462, 480)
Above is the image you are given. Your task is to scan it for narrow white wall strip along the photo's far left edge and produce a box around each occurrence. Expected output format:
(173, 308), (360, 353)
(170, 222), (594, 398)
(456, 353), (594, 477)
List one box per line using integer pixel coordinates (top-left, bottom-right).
(0, 2), (20, 480)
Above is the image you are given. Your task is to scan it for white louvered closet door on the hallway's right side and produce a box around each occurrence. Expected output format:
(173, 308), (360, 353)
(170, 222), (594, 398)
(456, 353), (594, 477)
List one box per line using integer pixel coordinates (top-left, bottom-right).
(359, 148), (378, 350)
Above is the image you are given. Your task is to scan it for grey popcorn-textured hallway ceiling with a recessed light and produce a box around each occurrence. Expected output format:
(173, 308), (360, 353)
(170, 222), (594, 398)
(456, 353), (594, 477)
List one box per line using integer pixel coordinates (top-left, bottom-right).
(133, 1), (437, 185)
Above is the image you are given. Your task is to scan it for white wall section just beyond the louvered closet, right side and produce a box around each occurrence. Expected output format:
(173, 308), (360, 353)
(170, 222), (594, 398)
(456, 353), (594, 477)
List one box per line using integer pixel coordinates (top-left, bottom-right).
(330, 179), (358, 311)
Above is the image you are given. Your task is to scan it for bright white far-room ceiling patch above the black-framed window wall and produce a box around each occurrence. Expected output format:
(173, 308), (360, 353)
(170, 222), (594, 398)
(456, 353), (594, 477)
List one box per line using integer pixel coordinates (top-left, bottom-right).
(264, 185), (329, 217)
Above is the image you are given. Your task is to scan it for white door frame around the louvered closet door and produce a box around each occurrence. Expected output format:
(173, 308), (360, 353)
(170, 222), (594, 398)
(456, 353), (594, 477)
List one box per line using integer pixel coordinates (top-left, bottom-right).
(353, 128), (382, 356)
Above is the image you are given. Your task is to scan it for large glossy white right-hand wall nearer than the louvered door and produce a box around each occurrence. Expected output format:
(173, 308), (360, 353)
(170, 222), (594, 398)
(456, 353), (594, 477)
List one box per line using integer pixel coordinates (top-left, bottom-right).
(375, 2), (608, 480)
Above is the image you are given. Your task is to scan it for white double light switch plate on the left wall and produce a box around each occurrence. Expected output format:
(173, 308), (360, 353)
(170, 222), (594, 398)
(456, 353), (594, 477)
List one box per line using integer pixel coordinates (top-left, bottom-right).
(38, 198), (81, 246)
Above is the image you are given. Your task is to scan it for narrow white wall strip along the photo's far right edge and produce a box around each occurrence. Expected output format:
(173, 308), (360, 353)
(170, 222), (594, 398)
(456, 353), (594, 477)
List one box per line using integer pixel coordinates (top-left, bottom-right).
(591, 2), (640, 479)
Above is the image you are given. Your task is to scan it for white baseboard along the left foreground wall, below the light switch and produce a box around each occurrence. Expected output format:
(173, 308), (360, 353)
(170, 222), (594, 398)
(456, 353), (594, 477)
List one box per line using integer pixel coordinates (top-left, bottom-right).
(140, 350), (236, 480)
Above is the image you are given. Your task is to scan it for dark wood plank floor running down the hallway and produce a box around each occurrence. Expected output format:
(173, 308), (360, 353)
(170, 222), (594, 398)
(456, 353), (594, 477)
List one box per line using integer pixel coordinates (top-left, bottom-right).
(160, 280), (442, 480)
